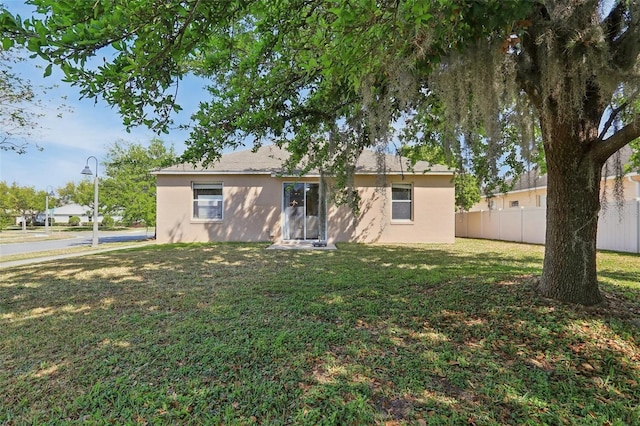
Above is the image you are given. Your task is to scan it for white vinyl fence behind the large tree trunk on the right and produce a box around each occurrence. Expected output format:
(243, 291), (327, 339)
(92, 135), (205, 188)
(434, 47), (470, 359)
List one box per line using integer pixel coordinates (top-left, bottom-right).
(456, 200), (640, 253)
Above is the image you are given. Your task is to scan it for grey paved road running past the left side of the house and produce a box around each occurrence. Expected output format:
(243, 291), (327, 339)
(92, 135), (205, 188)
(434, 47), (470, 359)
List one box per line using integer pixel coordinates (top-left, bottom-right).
(0, 228), (154, 256)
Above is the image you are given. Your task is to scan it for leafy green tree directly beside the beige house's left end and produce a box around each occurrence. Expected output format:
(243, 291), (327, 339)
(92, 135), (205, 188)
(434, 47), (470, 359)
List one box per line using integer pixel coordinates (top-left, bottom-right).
(102, 139), (176, 226)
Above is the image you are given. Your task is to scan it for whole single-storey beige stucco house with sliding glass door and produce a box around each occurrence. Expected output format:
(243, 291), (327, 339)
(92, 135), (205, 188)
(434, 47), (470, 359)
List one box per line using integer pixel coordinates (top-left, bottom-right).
(154, 145), (455, 243)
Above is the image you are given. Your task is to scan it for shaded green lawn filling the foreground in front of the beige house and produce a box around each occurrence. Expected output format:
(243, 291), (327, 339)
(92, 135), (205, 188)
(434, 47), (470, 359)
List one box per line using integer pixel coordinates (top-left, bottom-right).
(0, 240), (640, 425)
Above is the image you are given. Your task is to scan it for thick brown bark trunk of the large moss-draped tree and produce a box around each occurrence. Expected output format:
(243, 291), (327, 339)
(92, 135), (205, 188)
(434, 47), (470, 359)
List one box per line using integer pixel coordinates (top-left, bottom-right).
(540, 123), (603, 305)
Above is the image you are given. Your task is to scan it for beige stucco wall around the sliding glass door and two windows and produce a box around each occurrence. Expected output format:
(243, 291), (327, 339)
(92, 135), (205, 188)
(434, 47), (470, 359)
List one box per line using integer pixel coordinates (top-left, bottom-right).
(156, 174), (455, 243)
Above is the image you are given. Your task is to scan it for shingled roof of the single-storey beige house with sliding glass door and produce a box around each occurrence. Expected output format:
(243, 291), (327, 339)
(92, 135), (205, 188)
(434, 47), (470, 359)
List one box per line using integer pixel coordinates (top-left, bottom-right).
(154, 145), (453, 175)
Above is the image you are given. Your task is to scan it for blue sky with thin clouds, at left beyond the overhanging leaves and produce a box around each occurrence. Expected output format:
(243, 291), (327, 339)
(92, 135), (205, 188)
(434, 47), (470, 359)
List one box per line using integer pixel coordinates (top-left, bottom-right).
(0, 0), (203, 190)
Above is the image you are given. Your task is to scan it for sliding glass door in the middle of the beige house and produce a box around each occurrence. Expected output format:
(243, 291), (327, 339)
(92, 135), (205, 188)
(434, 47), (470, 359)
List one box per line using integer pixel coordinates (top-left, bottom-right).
(282, 183), (327, 240)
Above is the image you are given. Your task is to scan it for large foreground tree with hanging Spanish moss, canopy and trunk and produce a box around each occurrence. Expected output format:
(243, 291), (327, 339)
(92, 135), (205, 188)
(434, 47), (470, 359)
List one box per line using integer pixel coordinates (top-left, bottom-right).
(0, 0), (640, 304)
